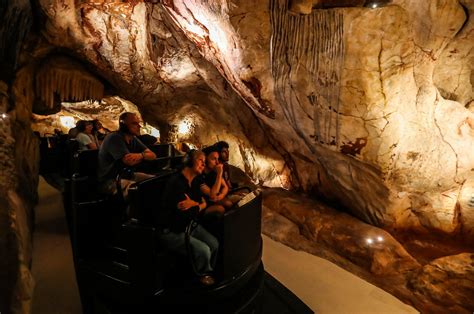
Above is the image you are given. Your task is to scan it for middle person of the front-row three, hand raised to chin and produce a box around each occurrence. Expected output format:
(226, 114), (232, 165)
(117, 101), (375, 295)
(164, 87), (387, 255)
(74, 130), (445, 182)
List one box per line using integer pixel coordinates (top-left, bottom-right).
(201, 145), (233, 214)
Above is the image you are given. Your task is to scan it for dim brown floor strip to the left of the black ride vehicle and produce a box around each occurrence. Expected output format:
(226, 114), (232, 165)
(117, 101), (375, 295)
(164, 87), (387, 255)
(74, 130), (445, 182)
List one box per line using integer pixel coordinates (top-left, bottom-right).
(32, 176), (82, 314)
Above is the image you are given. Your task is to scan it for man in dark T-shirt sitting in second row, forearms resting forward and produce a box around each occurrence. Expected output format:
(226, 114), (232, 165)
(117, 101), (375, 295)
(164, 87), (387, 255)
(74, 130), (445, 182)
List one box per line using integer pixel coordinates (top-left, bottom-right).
(98, 112), (156, 197)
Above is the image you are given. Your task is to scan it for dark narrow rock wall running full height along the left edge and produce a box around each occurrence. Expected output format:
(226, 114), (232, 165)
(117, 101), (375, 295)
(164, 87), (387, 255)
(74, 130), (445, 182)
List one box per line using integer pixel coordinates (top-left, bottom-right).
(0, 0), (39, 313)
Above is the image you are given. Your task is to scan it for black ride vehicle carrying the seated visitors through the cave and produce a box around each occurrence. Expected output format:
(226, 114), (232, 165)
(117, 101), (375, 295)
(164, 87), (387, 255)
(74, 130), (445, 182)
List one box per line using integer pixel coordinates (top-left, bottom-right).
(64, 146), (264, 313)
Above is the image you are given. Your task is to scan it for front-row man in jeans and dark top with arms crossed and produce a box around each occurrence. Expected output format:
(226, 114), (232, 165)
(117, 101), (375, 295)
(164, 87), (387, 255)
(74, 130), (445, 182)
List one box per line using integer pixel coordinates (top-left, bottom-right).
(160, 150), (219, 285)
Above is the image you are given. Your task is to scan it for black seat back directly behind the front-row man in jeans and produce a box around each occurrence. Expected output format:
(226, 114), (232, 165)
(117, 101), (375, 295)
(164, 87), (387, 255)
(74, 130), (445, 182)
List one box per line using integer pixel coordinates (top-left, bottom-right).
(128, 170), (175, 226)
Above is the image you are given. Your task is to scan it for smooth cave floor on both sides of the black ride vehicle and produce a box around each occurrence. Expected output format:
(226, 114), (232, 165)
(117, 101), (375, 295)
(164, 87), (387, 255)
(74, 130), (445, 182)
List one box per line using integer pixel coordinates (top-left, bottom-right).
(32, 177), (416, 314)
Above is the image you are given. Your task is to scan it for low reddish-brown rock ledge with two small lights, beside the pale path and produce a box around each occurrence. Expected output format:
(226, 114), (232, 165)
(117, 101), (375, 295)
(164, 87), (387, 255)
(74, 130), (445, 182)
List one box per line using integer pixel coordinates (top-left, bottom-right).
(262, 189), (474, 313)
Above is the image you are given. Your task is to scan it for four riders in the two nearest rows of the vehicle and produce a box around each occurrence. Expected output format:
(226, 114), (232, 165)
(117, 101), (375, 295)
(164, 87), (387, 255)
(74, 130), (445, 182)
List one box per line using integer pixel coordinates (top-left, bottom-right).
(97, 112), (243, 285)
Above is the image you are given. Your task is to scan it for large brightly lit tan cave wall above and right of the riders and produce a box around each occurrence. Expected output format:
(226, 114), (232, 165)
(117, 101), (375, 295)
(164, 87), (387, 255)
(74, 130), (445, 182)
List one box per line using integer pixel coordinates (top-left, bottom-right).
(41, 0), (474, 238)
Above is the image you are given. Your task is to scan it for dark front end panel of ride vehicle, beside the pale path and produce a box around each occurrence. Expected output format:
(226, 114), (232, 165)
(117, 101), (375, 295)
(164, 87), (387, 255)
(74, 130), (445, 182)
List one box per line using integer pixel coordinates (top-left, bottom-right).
(220, 191), (262, 279)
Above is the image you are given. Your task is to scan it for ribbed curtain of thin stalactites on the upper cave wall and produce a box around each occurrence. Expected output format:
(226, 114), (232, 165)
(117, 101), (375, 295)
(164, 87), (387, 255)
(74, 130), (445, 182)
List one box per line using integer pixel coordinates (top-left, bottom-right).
(270, 0), (344, 147)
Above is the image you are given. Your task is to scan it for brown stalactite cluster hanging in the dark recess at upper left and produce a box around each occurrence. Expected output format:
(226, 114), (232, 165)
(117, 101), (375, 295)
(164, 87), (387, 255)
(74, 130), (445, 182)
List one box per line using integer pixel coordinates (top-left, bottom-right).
(35, 57), (104, 108)
